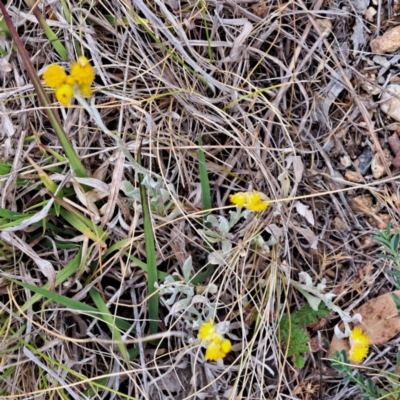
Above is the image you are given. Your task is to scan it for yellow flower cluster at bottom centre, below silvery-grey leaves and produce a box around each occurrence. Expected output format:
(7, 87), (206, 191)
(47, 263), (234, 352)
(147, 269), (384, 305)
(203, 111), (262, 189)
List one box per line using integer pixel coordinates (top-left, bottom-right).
(198, 319), (232, 361)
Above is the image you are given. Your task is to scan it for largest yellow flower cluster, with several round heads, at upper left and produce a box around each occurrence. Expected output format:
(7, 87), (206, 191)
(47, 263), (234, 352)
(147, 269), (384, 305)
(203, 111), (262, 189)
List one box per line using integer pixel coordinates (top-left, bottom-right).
(43, 56), (95, 106)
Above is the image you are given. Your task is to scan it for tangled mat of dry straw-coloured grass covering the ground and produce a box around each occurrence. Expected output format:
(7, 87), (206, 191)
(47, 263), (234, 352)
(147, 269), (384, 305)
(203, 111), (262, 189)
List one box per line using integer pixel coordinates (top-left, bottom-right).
(0, 0), (399, 400)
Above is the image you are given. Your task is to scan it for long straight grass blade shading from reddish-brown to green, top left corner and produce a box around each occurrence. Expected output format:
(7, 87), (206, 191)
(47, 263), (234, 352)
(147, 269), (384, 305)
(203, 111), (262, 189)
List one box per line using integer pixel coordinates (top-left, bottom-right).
(0, 2), (87, 178)
